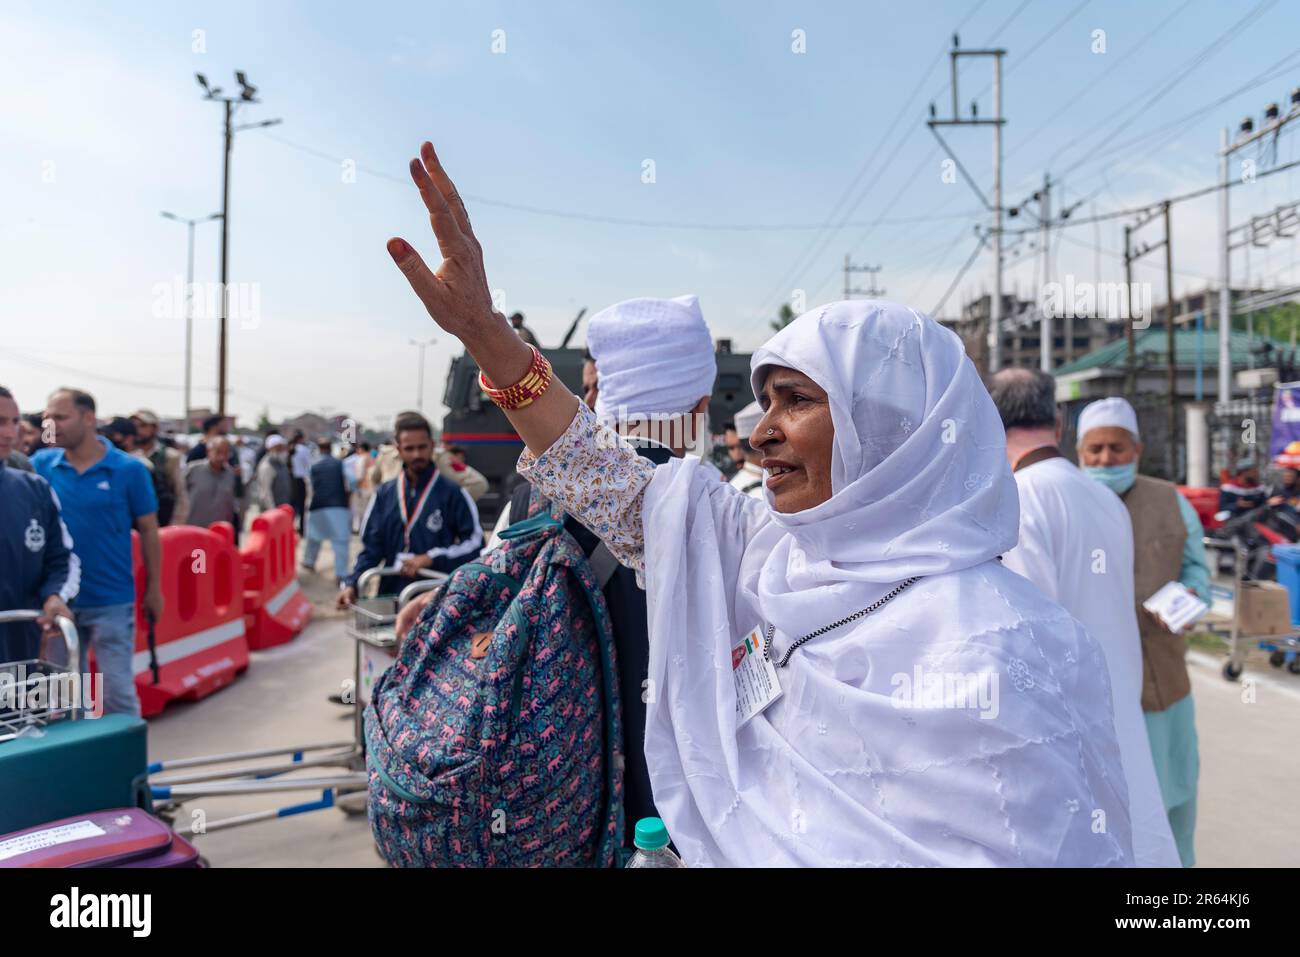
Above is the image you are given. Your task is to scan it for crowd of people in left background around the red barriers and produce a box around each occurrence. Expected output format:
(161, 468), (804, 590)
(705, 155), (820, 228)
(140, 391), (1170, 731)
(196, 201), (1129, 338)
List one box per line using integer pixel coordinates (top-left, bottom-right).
(0, 386), (488, 714)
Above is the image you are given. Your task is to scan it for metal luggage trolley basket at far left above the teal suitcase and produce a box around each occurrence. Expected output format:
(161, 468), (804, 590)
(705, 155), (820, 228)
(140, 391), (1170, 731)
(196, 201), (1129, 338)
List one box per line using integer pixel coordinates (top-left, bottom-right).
(0, 609), (83, 742)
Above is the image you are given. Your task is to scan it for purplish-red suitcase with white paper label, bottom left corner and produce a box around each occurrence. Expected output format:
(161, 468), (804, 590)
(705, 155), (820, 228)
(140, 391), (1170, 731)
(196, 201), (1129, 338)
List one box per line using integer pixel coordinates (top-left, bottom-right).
(0, 807), (199, 867)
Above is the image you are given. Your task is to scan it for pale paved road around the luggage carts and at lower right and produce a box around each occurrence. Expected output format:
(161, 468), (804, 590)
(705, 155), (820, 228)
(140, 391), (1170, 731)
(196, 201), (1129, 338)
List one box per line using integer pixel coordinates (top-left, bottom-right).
(142, 557), (1300, 867)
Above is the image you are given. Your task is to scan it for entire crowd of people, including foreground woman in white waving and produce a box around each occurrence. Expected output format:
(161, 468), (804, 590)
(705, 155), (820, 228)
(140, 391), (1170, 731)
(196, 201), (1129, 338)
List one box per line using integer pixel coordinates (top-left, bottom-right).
(0, 144), (1258, 866)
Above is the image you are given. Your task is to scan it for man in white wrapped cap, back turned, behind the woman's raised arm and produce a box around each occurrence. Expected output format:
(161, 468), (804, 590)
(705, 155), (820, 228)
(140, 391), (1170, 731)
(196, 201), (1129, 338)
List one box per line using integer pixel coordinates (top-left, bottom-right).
(489, 295), (722, 848)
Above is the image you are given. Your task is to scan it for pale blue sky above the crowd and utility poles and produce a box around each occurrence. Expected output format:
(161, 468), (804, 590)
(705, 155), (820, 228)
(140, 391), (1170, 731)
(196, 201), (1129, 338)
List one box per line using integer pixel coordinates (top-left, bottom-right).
(0, 0), (1300, 423)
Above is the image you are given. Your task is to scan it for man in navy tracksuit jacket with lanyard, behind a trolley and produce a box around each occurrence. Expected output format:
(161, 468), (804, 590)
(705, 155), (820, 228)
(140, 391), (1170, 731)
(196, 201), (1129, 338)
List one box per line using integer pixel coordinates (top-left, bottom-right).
(338, 412), (484, 607)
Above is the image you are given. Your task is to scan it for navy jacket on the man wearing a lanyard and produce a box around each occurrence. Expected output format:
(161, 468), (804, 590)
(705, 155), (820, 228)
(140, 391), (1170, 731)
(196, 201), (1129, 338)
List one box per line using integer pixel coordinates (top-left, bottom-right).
(347, 465), (484, 594)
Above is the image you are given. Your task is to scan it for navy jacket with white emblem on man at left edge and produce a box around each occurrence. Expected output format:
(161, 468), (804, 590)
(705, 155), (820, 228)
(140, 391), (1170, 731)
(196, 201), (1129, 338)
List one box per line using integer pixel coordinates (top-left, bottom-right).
(0, 462), (81, 662)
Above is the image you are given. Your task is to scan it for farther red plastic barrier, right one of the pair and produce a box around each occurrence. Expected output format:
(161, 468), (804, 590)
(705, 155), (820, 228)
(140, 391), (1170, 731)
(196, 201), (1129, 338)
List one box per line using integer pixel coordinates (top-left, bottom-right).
(239, 505), (312, 649)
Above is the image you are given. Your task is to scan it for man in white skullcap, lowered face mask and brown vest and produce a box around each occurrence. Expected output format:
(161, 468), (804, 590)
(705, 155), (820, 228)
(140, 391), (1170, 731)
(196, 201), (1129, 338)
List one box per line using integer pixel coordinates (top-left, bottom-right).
(1078, 397), (1210, 867)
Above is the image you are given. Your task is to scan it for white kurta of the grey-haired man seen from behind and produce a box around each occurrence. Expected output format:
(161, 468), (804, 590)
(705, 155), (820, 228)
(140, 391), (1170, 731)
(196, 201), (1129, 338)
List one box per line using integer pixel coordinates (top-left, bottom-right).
(1002, 458), (1179, 867)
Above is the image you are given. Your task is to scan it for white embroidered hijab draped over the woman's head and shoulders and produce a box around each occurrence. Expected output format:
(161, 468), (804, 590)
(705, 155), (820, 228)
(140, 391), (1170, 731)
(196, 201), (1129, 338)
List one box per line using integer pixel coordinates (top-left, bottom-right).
(642, 300), (1131, 866)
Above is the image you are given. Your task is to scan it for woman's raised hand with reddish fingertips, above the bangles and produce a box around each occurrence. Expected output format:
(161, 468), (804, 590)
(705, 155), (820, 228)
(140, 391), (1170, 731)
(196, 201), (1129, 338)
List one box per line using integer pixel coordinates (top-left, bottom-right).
(387, 143), (494, 345)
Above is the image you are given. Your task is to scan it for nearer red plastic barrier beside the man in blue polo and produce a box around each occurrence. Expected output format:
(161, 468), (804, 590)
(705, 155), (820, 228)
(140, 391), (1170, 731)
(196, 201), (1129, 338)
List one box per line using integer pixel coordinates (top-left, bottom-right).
(91, 521), (248, 718)
